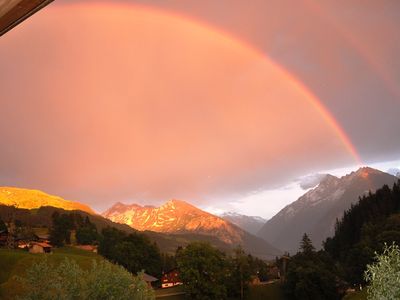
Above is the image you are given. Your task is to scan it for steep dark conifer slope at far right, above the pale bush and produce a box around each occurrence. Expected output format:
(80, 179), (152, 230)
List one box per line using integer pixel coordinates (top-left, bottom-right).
(324, 181), (400, 285)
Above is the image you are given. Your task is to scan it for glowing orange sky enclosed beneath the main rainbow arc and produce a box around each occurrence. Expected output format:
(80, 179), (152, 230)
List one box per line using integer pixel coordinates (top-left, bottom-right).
(0, 4), (398, 213)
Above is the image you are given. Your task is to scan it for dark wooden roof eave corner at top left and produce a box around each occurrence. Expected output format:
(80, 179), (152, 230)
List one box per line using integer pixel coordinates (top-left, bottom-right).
(0, 0), (53, 36)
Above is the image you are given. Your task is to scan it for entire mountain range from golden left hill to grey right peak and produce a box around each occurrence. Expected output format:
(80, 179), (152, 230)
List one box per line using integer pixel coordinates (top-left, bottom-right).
(0, 167), (399, 258)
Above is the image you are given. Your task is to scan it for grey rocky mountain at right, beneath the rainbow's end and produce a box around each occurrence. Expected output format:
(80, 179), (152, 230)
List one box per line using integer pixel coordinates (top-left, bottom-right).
(258, 168), (398, 253)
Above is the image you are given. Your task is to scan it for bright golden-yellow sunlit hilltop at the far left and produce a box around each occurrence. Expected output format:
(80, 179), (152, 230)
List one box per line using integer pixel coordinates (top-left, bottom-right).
(0, 187), (94, 214)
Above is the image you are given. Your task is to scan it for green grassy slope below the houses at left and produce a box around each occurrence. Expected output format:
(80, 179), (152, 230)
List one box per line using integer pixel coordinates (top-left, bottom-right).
(0, 247), (102, 299)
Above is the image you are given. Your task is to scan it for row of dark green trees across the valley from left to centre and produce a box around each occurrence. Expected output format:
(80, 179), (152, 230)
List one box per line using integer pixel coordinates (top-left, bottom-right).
(50, 212), (268, 299)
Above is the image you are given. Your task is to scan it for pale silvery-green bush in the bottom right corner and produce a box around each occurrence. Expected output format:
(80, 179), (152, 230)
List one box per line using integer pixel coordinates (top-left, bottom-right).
(364, 243), (400, 299)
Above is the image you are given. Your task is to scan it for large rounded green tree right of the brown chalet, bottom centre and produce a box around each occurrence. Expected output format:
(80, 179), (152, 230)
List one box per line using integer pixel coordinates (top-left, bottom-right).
(176, 242), (227, 300)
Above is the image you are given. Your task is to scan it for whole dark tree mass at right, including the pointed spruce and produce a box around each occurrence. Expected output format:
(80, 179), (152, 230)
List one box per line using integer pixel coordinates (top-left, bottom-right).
(284, 181), (400, 299)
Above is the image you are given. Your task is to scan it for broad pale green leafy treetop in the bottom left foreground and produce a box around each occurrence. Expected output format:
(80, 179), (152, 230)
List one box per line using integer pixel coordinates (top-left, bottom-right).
(18, 257), (154, 300)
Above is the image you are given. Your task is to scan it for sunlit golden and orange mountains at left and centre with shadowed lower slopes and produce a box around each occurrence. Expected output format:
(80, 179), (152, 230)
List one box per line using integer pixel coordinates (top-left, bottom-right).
(0, 187), (281, 258)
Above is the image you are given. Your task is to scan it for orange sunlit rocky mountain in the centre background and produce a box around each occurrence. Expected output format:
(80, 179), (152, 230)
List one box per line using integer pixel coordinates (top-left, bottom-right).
(102, 200), (280, 257)
